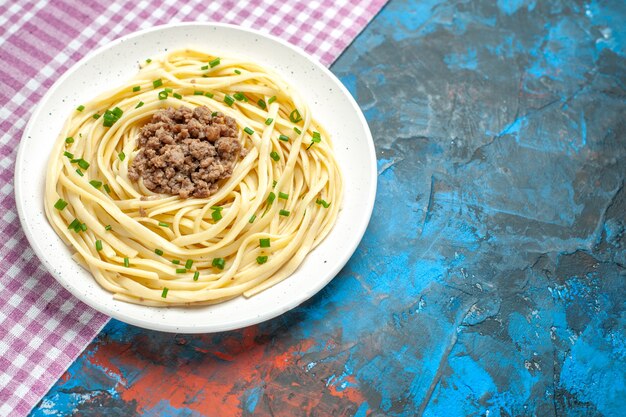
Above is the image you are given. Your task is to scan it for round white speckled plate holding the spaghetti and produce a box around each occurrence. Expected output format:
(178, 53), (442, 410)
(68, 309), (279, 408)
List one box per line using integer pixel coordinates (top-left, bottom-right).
(15, 23), (377, 333)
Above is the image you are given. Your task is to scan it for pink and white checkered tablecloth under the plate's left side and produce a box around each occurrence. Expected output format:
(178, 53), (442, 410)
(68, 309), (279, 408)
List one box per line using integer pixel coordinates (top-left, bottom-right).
(0, 0), (386, 416)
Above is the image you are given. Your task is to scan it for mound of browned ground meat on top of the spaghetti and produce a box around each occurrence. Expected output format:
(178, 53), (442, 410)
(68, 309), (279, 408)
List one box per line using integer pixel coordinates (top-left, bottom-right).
(128, 106), (242, 198)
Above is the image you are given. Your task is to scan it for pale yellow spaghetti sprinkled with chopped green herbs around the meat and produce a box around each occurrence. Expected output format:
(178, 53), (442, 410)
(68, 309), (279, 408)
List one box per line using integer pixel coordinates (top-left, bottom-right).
(44, 49), (342, 306)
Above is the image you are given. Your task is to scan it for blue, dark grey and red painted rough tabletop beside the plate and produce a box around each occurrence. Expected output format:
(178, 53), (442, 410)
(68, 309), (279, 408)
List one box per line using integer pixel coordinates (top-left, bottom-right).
(32, 0), (626, 417)
